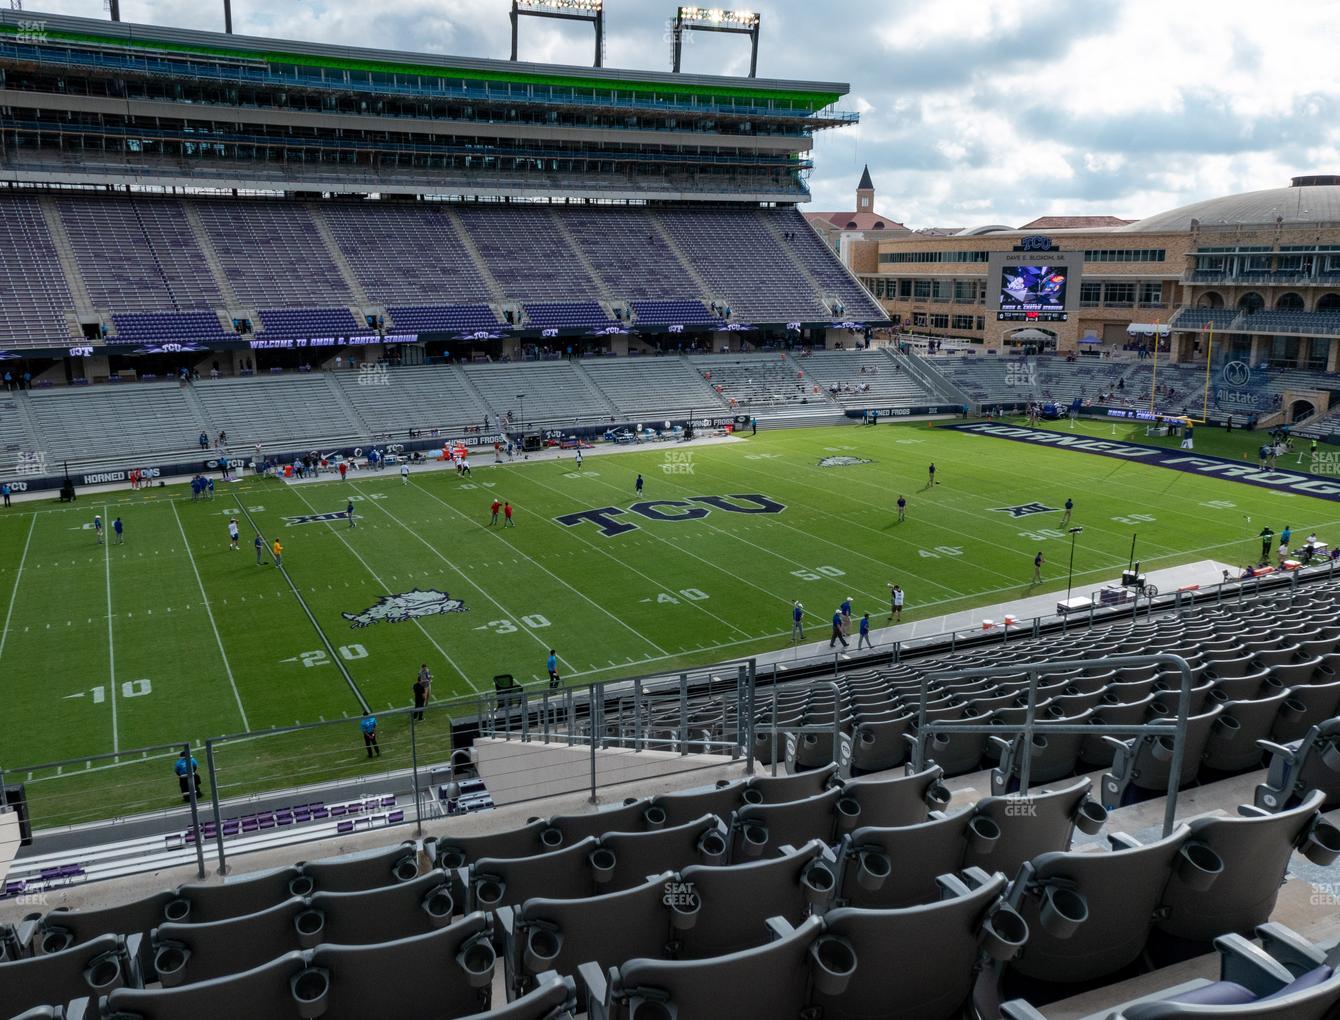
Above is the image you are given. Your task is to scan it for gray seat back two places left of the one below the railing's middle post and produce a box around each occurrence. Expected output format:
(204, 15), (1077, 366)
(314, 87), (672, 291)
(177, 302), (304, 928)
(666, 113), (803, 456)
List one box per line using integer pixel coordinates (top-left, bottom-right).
(671, 840), (836, 958)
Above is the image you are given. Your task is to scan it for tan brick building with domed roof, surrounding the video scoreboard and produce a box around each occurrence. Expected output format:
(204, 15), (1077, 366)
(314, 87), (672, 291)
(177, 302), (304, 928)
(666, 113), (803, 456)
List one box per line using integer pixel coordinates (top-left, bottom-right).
(846, 176), (1340, 371)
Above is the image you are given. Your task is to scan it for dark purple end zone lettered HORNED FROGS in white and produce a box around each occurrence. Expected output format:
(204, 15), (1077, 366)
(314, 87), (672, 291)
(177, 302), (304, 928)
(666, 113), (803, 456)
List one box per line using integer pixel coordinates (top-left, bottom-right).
(937, 421), (1340, 503)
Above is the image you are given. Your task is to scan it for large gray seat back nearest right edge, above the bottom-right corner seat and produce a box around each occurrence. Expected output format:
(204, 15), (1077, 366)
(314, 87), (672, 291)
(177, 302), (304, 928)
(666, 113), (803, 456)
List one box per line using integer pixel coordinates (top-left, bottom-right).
(1156, 791), (1340, 942)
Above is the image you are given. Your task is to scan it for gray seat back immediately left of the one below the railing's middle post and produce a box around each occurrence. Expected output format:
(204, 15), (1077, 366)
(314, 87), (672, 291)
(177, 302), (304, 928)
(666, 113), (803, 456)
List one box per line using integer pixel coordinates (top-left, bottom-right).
(836, 811), (973, 909)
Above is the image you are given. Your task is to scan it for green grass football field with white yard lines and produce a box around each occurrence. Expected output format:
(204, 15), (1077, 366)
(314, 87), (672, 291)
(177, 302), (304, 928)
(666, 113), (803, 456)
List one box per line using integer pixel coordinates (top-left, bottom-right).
(0, 422), (1340, 823)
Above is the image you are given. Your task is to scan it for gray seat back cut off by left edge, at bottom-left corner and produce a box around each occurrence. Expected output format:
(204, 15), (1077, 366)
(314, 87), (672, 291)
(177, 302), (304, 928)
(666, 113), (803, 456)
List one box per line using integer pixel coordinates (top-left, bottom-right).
(0, 934), (141, 1016)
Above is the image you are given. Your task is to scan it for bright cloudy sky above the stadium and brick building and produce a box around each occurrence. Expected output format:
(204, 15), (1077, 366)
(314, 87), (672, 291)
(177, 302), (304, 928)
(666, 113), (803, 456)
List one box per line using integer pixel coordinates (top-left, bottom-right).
(24, 0), (1340, 227)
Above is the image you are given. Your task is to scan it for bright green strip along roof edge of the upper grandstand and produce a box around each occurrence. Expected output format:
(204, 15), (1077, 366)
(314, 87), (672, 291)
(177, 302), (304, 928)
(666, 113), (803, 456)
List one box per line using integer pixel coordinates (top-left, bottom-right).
(0, 24), (842, 110)
